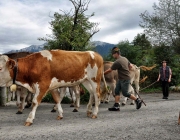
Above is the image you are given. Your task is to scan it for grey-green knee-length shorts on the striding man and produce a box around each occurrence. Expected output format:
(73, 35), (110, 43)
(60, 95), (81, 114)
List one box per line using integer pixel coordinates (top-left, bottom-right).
(115, 80), (131, 98)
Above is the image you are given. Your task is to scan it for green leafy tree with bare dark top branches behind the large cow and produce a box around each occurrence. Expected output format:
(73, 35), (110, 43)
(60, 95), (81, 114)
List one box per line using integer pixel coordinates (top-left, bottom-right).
(39, 0), (99, 50)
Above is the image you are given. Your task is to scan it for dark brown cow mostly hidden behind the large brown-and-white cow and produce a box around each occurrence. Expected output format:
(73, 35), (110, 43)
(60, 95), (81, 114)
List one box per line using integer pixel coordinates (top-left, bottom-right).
(6, 52), (83, 114)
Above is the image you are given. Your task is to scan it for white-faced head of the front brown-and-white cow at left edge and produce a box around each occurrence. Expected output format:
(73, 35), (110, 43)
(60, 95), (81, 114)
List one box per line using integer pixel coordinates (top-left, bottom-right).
(0, 55), (16, 87)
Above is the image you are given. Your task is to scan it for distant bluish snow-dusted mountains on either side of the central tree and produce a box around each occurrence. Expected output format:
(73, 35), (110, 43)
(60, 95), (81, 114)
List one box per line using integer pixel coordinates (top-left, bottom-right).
(5, 41), (115, 56)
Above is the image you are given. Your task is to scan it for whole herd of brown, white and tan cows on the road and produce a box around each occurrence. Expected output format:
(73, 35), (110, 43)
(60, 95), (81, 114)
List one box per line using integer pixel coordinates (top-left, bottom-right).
(0, 50), (180, 126)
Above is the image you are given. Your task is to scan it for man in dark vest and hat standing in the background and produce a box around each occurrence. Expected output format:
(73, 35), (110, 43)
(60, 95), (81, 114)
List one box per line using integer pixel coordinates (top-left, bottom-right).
(157, 60), (172, 99)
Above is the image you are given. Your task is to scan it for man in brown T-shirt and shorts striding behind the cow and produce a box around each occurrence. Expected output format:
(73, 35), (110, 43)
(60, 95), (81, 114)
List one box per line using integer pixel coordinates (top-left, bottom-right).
(104, 47), (142, 111)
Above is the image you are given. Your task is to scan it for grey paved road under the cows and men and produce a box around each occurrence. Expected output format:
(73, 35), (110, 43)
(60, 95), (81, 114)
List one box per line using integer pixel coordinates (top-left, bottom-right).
(0, 93), (180, 140)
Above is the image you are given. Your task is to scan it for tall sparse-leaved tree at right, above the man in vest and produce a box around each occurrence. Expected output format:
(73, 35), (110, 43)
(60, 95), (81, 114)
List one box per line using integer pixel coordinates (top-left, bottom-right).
(140, 0), (180, 46)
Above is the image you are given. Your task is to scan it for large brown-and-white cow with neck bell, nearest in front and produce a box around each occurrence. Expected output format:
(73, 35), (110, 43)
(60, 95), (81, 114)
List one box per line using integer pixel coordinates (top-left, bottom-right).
(0, 50), (104, 126)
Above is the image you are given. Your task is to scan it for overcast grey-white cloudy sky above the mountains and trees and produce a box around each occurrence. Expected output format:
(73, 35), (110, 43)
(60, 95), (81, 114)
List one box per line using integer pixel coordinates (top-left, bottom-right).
(0, 0), (158, 54)
